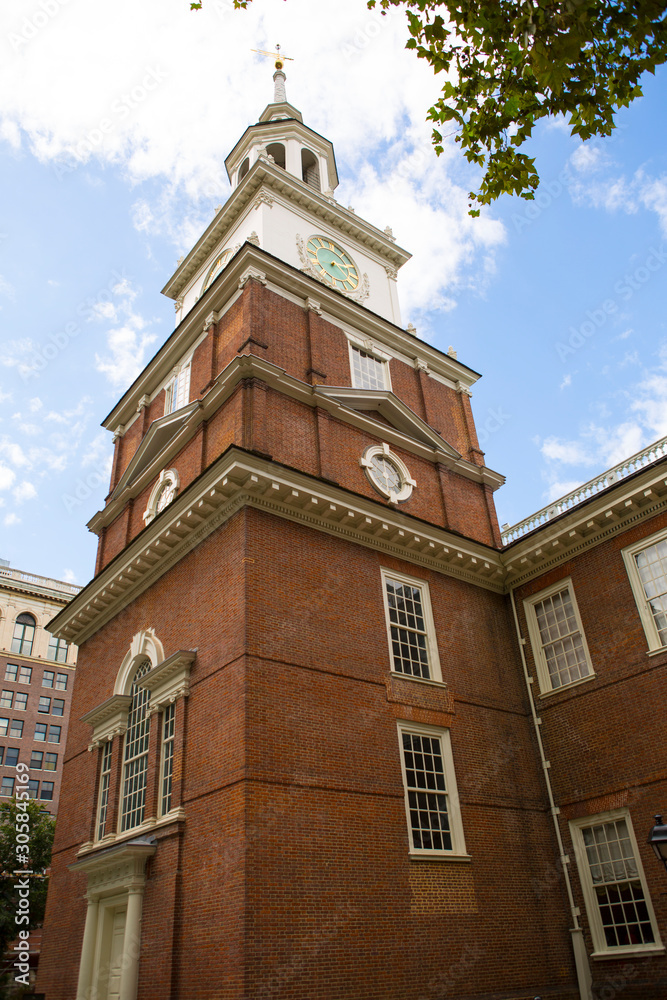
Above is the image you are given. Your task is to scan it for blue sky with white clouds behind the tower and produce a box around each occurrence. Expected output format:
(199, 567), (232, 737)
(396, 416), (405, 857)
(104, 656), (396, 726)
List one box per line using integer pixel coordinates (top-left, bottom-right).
(0, 0), (667, 583)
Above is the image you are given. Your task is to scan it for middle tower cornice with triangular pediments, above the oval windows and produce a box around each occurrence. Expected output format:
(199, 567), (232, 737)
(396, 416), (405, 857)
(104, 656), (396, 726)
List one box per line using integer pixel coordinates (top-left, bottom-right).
(88, 354), (505, 534)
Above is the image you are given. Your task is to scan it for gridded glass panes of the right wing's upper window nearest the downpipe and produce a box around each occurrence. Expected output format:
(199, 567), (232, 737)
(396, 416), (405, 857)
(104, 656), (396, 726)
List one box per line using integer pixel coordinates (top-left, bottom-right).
(533, 587), (590, 688)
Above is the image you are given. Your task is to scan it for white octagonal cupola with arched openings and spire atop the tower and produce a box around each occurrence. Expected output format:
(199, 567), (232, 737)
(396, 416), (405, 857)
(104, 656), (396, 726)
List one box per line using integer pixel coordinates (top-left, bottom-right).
(225, 59), (338, 197)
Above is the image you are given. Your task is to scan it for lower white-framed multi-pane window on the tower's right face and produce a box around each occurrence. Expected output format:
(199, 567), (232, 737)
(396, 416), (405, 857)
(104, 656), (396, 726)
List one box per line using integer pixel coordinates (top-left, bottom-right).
(398, 722), (465, 855)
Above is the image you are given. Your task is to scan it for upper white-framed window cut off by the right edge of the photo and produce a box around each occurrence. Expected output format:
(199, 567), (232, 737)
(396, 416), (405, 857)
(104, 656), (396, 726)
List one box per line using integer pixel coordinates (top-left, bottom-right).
(623, 531), (667, 649)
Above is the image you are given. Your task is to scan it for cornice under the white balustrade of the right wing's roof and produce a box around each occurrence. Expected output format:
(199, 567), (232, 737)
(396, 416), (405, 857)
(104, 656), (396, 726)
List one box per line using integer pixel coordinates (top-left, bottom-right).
(502, 459), (667, 589)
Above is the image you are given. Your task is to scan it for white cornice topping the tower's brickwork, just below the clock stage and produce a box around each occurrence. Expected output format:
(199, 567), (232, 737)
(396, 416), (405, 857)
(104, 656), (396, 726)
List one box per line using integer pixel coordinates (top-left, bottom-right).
(102, 244), (479, 431)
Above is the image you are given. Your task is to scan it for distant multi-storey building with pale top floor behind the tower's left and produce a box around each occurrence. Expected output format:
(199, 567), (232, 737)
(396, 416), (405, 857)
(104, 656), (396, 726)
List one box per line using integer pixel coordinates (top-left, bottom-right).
(0, 561), (81, 815)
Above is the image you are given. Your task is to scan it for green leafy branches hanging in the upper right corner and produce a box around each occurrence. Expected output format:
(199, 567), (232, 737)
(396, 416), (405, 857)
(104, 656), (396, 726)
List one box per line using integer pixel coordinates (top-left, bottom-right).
(190, 0), (667, 215)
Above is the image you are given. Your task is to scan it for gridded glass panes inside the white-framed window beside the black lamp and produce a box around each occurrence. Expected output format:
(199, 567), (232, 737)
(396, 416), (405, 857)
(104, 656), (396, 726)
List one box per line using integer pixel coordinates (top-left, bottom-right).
(581, 819), (655, 948)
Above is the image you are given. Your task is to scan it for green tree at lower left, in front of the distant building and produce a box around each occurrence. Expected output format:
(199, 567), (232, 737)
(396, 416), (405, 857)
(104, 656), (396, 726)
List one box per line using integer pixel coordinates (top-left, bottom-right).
(0, 798), (55, 956)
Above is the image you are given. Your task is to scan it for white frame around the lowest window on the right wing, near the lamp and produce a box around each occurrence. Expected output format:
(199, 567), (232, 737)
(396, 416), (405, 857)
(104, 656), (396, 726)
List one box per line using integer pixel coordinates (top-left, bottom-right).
(570, 809), (665, 959)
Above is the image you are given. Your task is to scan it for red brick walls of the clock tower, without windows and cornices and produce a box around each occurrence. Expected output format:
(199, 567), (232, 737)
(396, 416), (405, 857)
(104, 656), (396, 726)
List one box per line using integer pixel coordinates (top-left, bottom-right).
(38, 281), (578, 1000)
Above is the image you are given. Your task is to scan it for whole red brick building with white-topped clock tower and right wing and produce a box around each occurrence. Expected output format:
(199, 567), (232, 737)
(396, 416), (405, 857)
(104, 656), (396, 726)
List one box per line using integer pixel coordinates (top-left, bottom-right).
(39, 67), (667, 1000)
